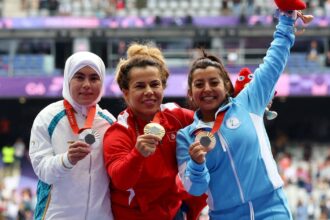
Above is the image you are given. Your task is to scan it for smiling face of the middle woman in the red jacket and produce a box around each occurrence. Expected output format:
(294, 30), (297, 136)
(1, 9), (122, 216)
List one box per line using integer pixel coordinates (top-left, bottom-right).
(123, 66), (164, 122)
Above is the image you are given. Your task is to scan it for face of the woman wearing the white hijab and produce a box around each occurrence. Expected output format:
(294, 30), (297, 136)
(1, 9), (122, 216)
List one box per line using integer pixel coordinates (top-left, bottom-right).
(69, 66), (102, 106)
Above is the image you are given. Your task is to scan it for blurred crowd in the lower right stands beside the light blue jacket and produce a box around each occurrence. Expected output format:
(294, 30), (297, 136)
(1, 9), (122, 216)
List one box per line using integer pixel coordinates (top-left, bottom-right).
(277, 144), (330, 220)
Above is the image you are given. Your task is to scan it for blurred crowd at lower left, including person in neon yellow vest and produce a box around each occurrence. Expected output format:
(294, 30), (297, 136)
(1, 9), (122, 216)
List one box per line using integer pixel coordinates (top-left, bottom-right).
(0, 138), (37, 220)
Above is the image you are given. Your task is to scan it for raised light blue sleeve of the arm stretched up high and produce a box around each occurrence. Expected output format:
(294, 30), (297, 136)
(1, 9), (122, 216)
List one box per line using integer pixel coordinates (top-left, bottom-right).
(236, 15), (295, 116)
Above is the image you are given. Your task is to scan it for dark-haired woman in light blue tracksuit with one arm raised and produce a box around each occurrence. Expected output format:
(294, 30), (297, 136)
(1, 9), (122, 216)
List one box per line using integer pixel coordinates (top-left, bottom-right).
(177, 11), (296, 220)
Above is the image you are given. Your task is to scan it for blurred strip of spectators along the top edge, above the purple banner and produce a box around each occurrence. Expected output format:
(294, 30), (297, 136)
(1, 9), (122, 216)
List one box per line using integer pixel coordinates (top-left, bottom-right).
(3, 0), (330, 17)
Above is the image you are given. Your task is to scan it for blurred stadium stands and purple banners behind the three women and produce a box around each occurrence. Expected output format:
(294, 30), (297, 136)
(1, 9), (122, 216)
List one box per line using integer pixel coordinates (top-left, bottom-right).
(0, 0), (330, 219)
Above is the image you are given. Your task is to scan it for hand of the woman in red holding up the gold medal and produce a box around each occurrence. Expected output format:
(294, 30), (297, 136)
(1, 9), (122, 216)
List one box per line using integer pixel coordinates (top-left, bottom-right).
(135, 134), (161, 157)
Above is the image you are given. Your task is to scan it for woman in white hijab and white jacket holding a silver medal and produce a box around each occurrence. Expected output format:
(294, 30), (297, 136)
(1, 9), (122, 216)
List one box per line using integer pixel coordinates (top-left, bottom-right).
(29, 52), (116, 220)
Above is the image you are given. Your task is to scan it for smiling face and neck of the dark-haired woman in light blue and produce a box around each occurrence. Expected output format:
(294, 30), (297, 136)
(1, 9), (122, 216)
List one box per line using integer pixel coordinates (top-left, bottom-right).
(188, 66), (227, 122)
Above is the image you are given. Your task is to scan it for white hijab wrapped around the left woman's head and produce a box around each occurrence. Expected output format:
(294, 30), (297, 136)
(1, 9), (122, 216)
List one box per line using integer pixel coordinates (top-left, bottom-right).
(62, 51), (105, 115)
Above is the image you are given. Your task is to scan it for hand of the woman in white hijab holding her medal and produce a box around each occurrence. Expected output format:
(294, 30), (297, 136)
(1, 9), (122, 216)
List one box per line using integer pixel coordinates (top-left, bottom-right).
(68, 141), (91, 165)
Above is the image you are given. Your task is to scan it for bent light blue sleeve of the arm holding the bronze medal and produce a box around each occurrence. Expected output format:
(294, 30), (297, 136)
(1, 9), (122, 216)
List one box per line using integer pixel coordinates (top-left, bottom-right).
(176, 129), (210, 196)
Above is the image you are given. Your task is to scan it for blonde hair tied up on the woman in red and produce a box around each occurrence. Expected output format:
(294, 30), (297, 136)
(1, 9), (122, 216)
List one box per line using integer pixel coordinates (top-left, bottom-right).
(116, 43), (169, 90)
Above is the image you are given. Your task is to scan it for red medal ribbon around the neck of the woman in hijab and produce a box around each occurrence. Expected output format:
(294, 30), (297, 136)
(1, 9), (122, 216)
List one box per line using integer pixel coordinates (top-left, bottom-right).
(63, 99), (96, 134)
